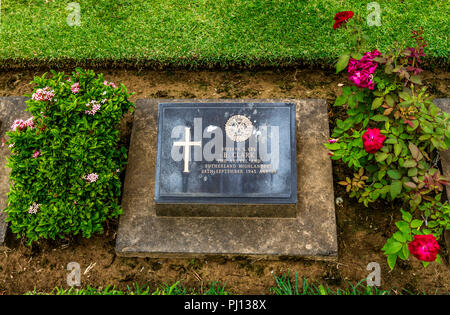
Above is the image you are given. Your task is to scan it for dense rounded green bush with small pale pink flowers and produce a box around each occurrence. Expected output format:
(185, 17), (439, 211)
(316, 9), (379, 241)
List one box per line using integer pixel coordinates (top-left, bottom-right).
(5, 69), (133, 243)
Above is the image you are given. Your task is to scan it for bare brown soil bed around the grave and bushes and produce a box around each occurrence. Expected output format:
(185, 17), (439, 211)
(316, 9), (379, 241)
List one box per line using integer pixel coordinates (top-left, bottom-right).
(0, 69), (450, 295)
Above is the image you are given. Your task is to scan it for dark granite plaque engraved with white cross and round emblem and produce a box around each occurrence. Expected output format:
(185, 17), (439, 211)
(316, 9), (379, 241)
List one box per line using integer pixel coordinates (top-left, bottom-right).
(155, 103), (297, 204)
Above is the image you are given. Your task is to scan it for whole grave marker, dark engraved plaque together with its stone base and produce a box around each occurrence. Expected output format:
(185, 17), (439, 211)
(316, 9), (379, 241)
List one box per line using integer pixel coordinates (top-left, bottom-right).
(116, 99), (337, 260)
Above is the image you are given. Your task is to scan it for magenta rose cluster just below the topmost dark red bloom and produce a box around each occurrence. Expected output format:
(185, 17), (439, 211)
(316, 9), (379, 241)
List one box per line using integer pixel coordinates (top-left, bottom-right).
(348, 49), (381, 90)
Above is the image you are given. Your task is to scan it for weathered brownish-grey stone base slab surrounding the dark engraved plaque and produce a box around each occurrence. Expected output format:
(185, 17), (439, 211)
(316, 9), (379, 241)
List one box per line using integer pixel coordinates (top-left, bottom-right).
(116, 99), (338, 260)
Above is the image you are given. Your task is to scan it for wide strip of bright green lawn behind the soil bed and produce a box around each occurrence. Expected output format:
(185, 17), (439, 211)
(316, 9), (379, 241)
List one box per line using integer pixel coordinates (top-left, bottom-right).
(0, 0), (450, 67)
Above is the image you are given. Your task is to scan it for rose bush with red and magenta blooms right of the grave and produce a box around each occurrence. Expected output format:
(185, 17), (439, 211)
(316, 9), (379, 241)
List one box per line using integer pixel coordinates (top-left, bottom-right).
(325, 11), (450, 268)
